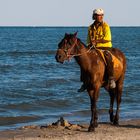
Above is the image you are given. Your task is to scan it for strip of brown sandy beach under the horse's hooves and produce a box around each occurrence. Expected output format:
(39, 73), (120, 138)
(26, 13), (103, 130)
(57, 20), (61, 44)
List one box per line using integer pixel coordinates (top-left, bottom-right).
(0, 120), (140, 140)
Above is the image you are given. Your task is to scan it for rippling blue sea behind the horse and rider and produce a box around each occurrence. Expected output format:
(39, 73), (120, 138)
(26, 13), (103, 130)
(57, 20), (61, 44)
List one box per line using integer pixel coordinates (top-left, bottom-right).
(0, 27), (140, 130)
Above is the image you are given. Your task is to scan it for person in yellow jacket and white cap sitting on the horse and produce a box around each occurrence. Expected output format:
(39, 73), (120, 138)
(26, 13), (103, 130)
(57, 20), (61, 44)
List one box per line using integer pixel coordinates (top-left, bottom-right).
(78, 8), (116, 92)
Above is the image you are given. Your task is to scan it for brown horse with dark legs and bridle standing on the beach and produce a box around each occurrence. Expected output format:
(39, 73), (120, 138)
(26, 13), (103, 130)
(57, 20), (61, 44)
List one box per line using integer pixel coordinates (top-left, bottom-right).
(56, 33), (126, 131)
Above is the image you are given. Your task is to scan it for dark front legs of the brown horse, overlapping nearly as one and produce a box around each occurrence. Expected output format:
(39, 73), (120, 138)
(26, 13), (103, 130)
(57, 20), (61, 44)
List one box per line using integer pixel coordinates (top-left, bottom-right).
(88, 89), (99, 132)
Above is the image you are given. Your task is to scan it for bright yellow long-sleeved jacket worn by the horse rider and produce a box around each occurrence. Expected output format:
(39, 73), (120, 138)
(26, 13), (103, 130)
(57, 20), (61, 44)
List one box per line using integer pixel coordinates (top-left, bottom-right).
(87, 22), (112, 48)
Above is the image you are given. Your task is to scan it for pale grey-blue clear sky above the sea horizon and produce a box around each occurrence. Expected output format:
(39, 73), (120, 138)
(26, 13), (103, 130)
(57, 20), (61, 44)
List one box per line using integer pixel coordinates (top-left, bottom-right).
(0, 0), (140, 26)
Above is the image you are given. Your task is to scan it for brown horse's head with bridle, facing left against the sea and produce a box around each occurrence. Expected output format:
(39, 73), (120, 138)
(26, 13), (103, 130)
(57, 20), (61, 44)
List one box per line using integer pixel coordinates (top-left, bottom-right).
(55, 32), (77, 63)
